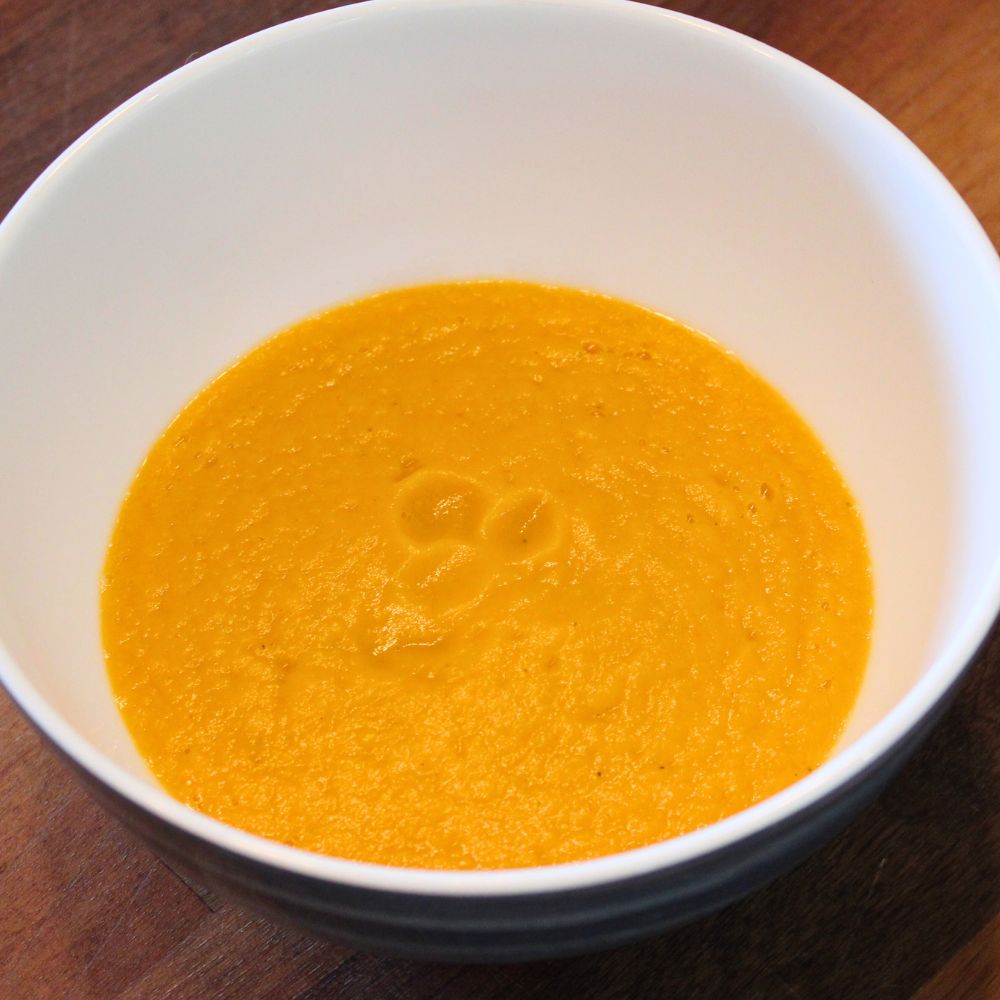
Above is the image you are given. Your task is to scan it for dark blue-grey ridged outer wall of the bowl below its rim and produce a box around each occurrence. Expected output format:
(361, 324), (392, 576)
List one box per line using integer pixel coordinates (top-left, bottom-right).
(42, 685), (958, 962)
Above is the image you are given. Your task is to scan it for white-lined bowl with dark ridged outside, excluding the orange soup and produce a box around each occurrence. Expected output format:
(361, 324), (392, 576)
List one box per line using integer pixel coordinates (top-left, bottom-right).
(0, 0), (1000, 958)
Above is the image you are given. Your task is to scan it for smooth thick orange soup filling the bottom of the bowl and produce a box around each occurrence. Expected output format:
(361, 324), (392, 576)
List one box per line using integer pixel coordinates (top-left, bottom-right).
(102, 281), (872, 868)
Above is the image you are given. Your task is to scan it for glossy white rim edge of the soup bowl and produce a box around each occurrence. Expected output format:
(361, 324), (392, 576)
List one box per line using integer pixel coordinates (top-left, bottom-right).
(0, 0), (1000, 898)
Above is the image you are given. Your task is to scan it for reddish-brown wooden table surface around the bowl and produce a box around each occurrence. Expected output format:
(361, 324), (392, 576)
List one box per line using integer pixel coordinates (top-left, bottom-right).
(0, 0), (1000, 1000)
